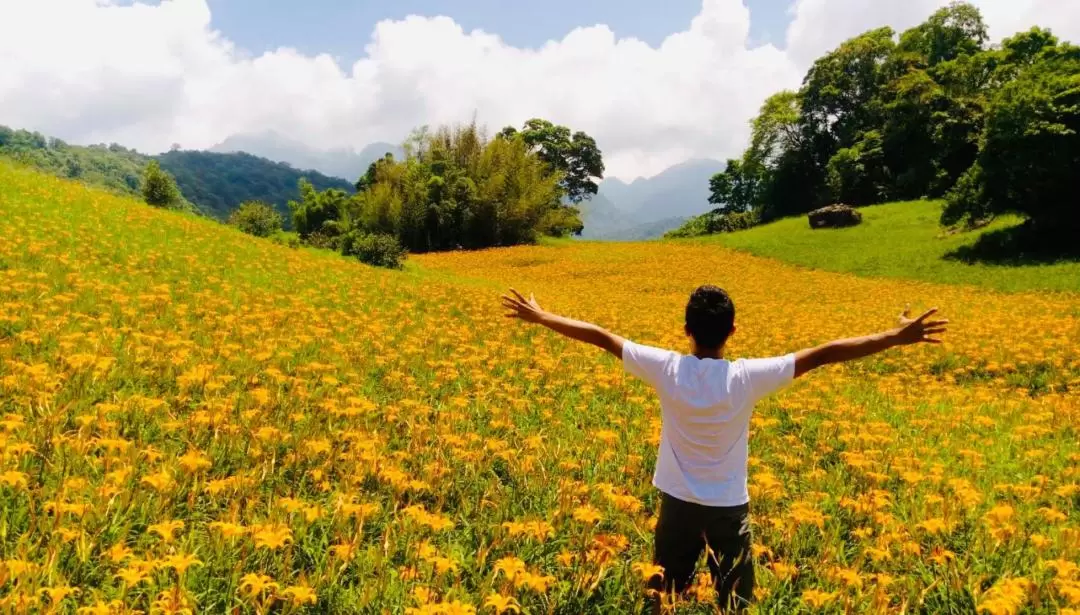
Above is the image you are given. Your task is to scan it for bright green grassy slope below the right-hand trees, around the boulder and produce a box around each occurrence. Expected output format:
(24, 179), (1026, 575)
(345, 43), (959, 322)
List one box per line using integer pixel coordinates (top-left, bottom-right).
(689, 201), (1080, 291)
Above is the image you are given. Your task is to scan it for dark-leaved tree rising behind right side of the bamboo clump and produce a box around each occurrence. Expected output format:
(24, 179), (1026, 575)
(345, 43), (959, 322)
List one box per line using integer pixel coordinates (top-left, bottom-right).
(498, 119), (604, 204)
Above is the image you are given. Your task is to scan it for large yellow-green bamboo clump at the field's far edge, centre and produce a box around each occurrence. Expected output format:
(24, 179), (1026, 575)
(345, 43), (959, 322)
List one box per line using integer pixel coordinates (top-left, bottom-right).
(343, 124), (582, 252)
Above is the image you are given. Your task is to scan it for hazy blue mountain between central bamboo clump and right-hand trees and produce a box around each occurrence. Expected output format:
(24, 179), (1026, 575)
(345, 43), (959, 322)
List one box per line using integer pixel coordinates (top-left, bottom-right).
(582, 159), (724, 241)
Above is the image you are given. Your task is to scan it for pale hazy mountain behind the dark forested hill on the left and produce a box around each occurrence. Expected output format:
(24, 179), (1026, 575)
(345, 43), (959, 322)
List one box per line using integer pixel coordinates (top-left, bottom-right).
(210, 131), (405, 183)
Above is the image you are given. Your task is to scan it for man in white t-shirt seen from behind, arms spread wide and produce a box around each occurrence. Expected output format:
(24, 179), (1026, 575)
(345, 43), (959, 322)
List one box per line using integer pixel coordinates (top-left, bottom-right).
(502, 285), (948, 612)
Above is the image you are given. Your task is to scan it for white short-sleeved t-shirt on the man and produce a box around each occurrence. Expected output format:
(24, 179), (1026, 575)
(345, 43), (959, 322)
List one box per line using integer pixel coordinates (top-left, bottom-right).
(622, 340), (795, 506)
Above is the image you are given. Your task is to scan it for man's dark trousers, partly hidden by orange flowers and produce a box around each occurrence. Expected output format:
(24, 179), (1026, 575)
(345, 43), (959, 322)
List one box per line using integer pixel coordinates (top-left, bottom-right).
(648, 493), (754, 612)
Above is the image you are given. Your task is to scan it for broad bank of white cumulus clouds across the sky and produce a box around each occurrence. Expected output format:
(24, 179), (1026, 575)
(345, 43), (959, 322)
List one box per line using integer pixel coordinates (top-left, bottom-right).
(0, 0), (1080, 177)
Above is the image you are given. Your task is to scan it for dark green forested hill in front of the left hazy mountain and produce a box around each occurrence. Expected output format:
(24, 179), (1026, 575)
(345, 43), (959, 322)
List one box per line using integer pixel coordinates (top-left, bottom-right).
(156, 151), (355, 224)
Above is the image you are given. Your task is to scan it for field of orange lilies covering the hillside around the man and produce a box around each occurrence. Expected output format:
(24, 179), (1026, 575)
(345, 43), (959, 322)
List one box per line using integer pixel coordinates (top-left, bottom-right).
(0, 162), (1080, 614)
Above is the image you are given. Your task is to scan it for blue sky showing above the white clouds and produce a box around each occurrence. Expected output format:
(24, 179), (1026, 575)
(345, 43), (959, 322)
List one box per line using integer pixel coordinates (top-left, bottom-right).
(210, 0), (792, 63)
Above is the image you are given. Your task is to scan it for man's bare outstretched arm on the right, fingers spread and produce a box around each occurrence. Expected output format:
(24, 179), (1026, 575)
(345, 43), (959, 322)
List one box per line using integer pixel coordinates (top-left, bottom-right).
(795, 308), (948, 378)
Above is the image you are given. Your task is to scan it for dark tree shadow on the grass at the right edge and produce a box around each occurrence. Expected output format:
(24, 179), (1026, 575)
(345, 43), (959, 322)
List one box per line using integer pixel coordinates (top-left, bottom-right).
(945, 223), (1080, 267)
